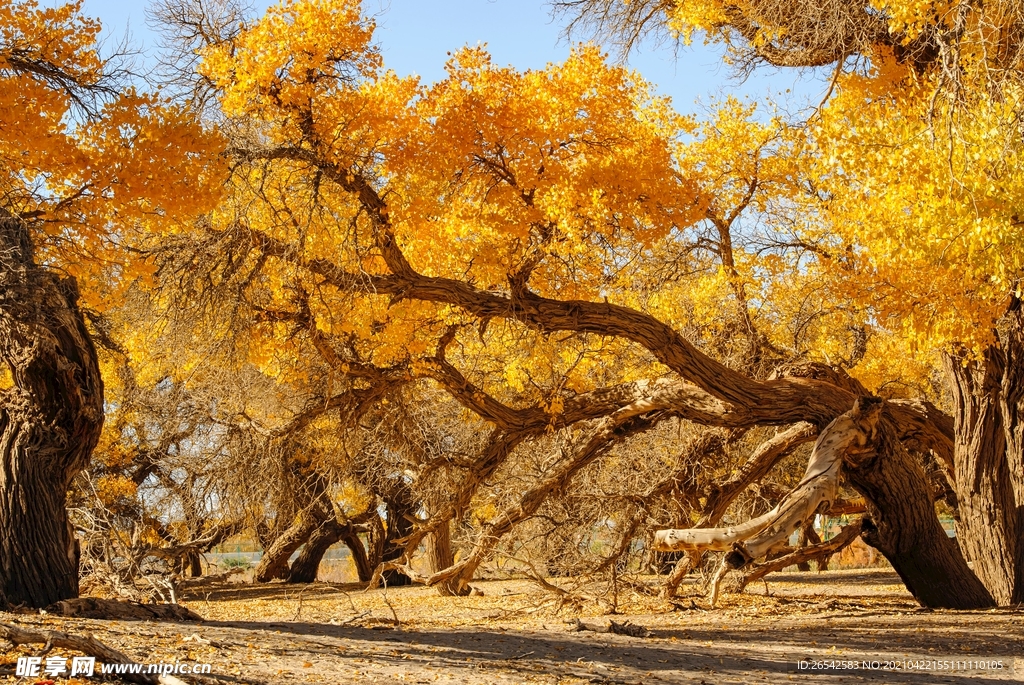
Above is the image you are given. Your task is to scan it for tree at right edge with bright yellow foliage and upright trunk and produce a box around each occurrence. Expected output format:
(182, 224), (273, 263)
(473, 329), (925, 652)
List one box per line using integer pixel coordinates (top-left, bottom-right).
(557, 0), (1024, 604)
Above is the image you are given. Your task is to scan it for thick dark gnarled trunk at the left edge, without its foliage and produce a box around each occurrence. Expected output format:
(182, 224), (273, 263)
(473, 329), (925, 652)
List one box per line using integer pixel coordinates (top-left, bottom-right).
(0, 215), (103, 607)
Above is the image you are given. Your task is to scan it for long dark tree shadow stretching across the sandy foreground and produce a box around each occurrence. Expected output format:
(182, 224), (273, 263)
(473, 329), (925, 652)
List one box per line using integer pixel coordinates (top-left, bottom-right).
(190, 622), (1020, 685)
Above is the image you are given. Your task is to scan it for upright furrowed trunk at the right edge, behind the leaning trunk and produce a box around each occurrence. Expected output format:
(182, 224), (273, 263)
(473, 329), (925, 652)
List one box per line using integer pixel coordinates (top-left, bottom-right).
(946, 299), (1024, 605)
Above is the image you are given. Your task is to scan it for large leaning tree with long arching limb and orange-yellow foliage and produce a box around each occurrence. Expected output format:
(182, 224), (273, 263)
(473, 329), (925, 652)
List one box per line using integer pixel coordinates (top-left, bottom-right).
(172, 0), (991, 606)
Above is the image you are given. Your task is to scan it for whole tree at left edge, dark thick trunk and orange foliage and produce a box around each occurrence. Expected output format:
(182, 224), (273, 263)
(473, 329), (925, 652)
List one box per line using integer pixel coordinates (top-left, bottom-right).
(0, 1), (216, 607)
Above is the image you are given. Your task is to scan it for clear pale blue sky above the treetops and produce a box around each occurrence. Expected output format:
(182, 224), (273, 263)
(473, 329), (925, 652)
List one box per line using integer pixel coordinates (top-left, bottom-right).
(83, 0), (826, 113)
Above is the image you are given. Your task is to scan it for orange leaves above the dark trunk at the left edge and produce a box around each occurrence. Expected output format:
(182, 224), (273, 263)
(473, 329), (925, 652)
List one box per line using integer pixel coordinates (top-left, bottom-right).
(0, 0), (220, 308)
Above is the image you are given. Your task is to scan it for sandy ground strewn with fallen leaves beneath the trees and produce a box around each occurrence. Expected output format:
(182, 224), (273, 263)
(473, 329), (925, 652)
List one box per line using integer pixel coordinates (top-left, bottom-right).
(0, 570), (1024, 685)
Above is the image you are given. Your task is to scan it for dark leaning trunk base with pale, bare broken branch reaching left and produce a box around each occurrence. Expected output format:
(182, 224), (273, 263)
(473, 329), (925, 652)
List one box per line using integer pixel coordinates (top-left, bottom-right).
(655, 398), (992, 609)
